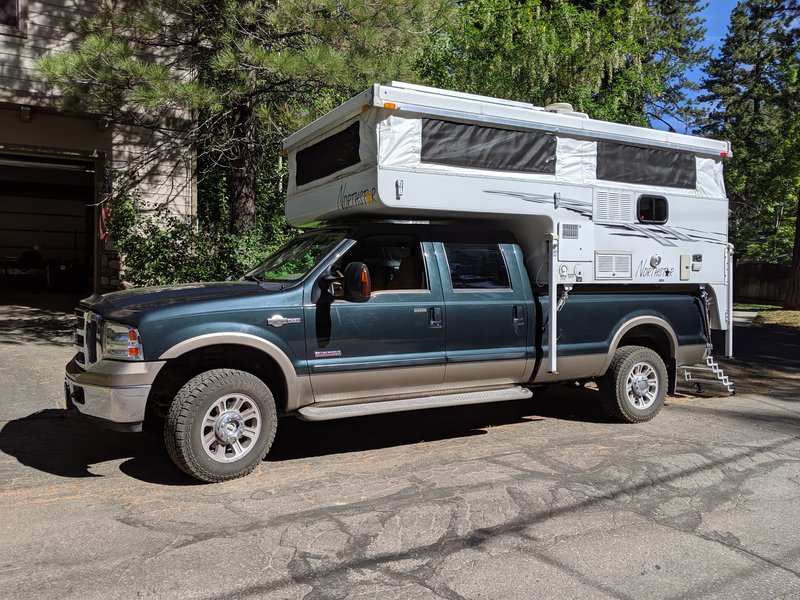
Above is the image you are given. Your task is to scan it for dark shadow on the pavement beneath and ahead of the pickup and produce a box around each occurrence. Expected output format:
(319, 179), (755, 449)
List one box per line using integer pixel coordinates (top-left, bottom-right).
(0, 386), (608, 486)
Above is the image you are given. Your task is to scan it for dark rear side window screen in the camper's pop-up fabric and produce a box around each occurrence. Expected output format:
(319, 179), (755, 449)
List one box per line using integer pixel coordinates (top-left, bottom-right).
(597, 141), (697, 189)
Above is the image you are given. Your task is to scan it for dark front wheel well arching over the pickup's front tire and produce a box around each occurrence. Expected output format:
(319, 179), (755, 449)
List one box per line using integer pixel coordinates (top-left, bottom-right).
(148, 344), (287, 417)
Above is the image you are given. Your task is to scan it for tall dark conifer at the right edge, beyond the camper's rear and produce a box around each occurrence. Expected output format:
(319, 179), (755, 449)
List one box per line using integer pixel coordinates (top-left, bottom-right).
(701, 0), (800, 262)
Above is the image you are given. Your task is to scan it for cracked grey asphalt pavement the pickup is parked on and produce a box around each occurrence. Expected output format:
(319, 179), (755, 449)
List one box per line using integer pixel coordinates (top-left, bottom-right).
(0, 294), (800, 600)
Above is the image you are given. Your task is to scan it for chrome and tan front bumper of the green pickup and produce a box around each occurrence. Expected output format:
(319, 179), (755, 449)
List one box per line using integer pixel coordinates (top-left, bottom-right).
(64, 359), (165, 431)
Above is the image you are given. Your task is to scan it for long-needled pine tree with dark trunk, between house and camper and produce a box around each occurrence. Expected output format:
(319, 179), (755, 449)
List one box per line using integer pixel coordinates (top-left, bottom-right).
(39, 0), (447, 233)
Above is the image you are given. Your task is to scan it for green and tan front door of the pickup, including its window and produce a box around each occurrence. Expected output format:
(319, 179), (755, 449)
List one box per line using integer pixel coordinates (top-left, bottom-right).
(304, 234), (445, 402)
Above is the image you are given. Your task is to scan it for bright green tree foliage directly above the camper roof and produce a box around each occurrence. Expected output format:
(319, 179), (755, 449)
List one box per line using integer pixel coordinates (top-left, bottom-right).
(418, 0), (707, 125)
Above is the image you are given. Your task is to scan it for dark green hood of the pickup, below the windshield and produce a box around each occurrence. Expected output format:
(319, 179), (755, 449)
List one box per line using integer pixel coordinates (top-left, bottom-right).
(81, 281), (281, 322)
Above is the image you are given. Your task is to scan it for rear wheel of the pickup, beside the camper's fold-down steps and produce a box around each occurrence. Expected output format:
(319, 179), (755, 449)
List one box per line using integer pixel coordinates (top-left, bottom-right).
(599, 346), (667, 423)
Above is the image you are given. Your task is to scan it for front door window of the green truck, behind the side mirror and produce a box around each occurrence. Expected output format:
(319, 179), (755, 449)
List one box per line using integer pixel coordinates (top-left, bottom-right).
(339, 235), (429, 292)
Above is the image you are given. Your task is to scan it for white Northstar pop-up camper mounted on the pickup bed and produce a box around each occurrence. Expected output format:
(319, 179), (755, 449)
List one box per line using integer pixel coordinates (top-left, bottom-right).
(284, 82), (732, 346)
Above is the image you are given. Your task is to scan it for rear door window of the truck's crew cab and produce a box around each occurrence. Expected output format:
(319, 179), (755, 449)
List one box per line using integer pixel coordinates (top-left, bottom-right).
(444, 243), (511, 290)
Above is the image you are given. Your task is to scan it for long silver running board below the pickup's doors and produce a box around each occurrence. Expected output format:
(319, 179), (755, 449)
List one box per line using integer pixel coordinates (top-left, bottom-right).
(298, 387), (533, 421)
